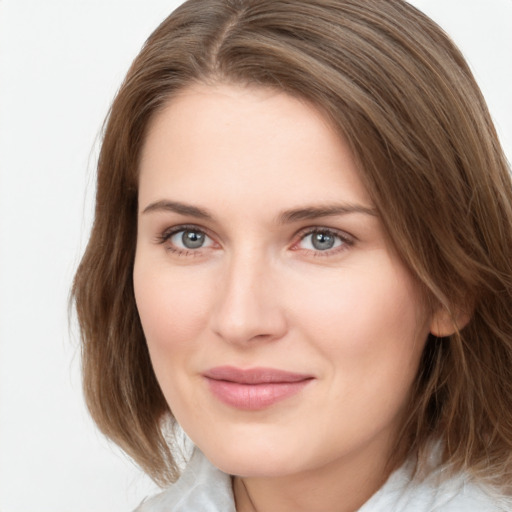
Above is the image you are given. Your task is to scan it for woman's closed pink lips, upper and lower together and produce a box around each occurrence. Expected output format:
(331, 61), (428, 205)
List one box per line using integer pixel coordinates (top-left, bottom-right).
(203, 366), (313, 411)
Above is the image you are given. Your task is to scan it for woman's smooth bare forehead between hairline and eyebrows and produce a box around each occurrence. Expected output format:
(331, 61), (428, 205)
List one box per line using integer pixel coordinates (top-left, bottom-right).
(139, 84), (370, 212)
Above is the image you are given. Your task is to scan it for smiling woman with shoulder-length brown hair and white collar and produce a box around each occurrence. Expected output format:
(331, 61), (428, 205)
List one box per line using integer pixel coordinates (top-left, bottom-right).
(74, 0), (512, 512)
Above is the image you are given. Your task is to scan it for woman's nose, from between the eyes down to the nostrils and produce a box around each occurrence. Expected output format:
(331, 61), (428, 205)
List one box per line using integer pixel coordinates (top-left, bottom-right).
(211, 254), (287, 345)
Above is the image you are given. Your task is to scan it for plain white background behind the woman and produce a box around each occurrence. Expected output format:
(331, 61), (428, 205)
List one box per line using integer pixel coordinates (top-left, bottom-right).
(0, 0), (512, 512)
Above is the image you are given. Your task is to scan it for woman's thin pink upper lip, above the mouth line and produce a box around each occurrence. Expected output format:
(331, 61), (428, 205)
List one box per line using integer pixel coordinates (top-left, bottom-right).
(203, 366), (313, 384)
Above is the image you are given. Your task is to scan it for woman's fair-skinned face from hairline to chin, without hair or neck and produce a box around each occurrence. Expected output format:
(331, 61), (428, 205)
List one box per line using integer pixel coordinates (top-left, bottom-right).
(134, 85), (433, 476)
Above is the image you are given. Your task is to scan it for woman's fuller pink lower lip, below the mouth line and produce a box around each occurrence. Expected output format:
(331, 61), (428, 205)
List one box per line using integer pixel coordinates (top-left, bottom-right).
(207, 378), (312, 411)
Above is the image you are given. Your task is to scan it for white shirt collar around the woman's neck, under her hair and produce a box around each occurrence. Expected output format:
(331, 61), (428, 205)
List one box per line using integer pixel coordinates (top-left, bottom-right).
(135, 448), (512, 512)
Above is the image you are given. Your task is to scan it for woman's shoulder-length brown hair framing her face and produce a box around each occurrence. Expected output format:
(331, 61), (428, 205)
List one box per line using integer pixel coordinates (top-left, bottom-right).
(73, 0), (512, 485)
